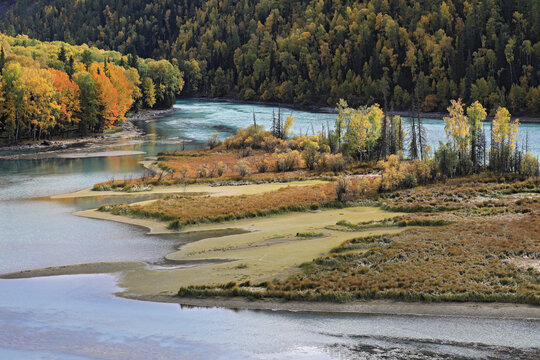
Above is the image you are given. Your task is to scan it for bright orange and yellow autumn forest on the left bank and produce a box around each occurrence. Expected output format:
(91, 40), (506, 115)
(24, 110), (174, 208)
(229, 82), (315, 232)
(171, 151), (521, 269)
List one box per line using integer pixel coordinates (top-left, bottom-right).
(0, 34), (183, 143)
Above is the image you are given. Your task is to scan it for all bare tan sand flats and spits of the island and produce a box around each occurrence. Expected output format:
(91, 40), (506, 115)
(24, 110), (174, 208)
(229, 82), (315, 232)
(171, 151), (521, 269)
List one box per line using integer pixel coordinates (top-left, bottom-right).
(0, 176), (540, 320)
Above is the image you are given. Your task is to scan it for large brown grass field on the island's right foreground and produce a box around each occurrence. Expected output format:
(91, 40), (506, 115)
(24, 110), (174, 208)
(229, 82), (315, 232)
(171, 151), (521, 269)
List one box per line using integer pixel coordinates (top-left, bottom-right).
(179, 179), (540, 304)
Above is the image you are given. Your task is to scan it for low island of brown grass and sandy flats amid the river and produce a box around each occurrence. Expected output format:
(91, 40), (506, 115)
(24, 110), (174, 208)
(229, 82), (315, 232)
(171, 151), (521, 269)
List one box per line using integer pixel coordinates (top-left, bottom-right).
(5, 99), (539, 318)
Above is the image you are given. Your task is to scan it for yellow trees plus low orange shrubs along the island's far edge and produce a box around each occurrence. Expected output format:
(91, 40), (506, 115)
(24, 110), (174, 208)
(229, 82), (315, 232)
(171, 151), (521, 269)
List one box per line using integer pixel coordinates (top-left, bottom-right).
(223, 99), (540, 186)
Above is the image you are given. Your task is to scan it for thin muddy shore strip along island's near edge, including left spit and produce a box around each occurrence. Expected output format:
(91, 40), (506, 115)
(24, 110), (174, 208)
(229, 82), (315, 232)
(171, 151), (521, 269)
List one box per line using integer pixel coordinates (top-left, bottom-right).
(0, 261), (540, 321)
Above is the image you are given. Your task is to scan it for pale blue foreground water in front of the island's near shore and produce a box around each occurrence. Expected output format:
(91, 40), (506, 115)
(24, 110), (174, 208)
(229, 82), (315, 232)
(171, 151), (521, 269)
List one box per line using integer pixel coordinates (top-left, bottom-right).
(0, 275), (540, 359)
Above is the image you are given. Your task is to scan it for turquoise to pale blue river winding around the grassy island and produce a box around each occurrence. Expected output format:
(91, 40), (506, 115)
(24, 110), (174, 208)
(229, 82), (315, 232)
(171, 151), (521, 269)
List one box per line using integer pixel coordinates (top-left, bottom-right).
(0, 100), (540, 359)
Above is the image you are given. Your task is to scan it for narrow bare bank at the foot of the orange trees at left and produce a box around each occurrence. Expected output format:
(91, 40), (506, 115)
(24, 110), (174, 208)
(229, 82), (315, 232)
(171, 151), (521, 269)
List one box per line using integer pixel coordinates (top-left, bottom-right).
(0, 108), (177, 160)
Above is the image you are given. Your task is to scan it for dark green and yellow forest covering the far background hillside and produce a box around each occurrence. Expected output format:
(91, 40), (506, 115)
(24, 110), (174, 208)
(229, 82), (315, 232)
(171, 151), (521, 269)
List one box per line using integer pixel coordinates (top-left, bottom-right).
(0, 0), (540, 115)
